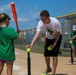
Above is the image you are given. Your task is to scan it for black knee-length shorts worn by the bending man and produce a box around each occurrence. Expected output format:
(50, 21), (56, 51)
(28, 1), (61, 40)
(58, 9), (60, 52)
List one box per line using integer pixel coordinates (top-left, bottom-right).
(44, 35), (62, 57)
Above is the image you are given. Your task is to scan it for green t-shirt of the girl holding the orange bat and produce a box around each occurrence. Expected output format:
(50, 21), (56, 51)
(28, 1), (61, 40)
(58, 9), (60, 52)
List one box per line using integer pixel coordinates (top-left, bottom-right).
(0, 27), (19, 60)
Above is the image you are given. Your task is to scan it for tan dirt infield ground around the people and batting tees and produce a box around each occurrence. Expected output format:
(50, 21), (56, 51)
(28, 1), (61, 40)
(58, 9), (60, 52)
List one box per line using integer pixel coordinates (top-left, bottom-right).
(2, 49), (76, 75)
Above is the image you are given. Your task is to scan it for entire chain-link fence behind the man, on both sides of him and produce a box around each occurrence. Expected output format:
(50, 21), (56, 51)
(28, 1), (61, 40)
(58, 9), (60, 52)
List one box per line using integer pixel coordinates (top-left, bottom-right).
(16, 16), (76, 48)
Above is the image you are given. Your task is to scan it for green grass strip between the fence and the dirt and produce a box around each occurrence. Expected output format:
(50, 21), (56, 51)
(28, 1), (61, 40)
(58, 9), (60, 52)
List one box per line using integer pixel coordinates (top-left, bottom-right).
(15, 44), (70, 57)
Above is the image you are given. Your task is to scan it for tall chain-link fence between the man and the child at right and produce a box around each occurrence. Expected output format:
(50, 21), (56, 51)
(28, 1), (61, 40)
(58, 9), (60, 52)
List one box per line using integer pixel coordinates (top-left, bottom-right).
(59, 16), (76, 48)
